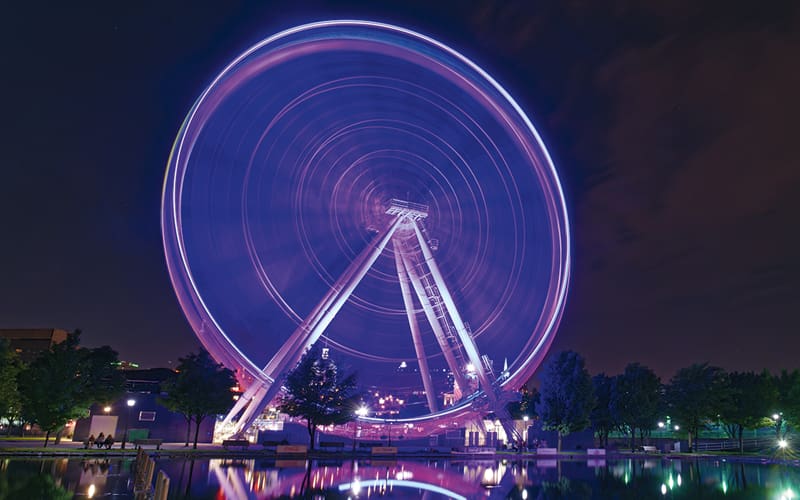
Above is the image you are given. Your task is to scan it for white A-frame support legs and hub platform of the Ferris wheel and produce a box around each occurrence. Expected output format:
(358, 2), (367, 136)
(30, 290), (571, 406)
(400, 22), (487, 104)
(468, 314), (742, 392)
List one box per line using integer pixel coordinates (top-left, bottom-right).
(223, 200), (506, 436)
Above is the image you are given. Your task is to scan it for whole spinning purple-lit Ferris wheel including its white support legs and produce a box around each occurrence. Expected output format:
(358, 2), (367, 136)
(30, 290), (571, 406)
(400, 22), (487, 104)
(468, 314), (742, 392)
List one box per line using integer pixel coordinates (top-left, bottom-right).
(162, 21), (569, 438)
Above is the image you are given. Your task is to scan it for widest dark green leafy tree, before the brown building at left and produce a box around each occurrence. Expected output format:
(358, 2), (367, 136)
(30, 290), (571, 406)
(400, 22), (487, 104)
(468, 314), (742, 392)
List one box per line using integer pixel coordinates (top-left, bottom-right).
(18, 330), (125, 447)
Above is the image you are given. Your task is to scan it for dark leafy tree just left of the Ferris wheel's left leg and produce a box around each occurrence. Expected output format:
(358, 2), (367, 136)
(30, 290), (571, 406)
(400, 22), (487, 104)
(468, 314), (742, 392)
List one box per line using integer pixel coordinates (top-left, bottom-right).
(161, 348), (236, 449)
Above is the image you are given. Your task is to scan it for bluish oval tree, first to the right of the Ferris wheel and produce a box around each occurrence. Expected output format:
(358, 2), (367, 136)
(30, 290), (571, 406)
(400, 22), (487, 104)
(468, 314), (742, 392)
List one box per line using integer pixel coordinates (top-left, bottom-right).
(537, 351), (595, 451)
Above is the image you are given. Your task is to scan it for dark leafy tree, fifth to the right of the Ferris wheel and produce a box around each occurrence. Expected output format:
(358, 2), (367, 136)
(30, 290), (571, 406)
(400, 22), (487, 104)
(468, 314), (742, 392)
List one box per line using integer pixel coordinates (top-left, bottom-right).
(719, 372), (778, 452)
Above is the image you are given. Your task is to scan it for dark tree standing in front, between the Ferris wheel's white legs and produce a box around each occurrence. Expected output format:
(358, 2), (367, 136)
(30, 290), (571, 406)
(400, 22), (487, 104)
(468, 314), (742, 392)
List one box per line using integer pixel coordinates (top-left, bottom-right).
(279, 345), (361, 450)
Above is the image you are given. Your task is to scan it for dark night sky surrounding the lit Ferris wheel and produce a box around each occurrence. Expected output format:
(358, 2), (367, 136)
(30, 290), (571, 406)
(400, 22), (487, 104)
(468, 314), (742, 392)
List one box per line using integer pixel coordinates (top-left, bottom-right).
(6, 1), (800, 378)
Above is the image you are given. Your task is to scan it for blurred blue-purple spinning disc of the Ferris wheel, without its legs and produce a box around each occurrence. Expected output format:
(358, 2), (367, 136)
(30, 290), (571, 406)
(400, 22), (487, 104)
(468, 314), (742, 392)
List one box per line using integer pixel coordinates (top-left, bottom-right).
(162, 20), (571, 428)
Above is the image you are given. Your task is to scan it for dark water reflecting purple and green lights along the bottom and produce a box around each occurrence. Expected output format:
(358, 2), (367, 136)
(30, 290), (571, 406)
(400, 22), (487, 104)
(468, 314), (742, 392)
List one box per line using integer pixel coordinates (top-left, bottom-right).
(0, 458), (800, 500)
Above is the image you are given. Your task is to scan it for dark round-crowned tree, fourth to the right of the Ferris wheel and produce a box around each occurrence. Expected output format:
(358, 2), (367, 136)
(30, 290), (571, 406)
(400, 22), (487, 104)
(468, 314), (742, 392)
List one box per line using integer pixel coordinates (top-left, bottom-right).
(666, 363), (728, 451)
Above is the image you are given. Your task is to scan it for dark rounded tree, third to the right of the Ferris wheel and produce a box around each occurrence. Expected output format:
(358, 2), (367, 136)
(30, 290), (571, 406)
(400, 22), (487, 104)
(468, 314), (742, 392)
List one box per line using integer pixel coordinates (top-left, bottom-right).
(612, 363), (661, 449)
